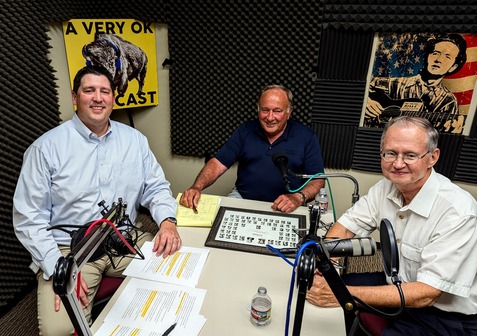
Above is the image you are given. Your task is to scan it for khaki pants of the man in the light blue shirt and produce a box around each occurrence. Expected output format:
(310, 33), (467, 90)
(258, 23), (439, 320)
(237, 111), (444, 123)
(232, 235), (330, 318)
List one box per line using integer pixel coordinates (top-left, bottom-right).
(37, 227), (154, 336)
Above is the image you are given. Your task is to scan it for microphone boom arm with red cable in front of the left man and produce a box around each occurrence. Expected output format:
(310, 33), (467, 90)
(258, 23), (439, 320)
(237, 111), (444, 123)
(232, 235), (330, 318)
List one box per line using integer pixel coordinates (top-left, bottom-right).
(53, 198), (126, 336)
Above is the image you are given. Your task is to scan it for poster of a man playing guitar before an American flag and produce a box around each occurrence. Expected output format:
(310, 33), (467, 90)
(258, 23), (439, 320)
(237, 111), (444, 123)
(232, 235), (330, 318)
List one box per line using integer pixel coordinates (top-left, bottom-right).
(361, 33), (477, 135)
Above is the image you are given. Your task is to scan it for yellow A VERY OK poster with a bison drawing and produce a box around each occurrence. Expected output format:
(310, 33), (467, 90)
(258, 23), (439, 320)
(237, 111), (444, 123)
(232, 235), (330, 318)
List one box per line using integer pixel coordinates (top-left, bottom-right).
(63, 19), (158, 109)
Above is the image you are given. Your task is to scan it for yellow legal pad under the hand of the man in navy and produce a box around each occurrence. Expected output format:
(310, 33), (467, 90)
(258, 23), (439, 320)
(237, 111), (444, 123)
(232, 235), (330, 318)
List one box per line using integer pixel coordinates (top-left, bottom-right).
(176, 193), (220, 227)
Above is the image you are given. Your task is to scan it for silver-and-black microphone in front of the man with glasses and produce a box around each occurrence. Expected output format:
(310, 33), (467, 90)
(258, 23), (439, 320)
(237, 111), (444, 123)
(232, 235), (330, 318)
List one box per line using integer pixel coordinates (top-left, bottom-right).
(280, 237), (376, 257)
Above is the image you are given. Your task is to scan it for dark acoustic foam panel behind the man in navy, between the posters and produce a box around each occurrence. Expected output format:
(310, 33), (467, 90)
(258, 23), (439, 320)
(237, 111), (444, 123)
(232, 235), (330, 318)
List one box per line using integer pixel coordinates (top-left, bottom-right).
(169, 0), (322, 157)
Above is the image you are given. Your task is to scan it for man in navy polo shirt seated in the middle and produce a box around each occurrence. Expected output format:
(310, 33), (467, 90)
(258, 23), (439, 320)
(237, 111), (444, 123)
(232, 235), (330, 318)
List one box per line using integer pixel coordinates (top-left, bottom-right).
(180, 85), (324, 212)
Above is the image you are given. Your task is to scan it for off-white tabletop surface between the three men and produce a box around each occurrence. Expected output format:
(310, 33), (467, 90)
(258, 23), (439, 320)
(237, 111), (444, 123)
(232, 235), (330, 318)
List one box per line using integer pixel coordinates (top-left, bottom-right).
(92, 197), (346, 336)
